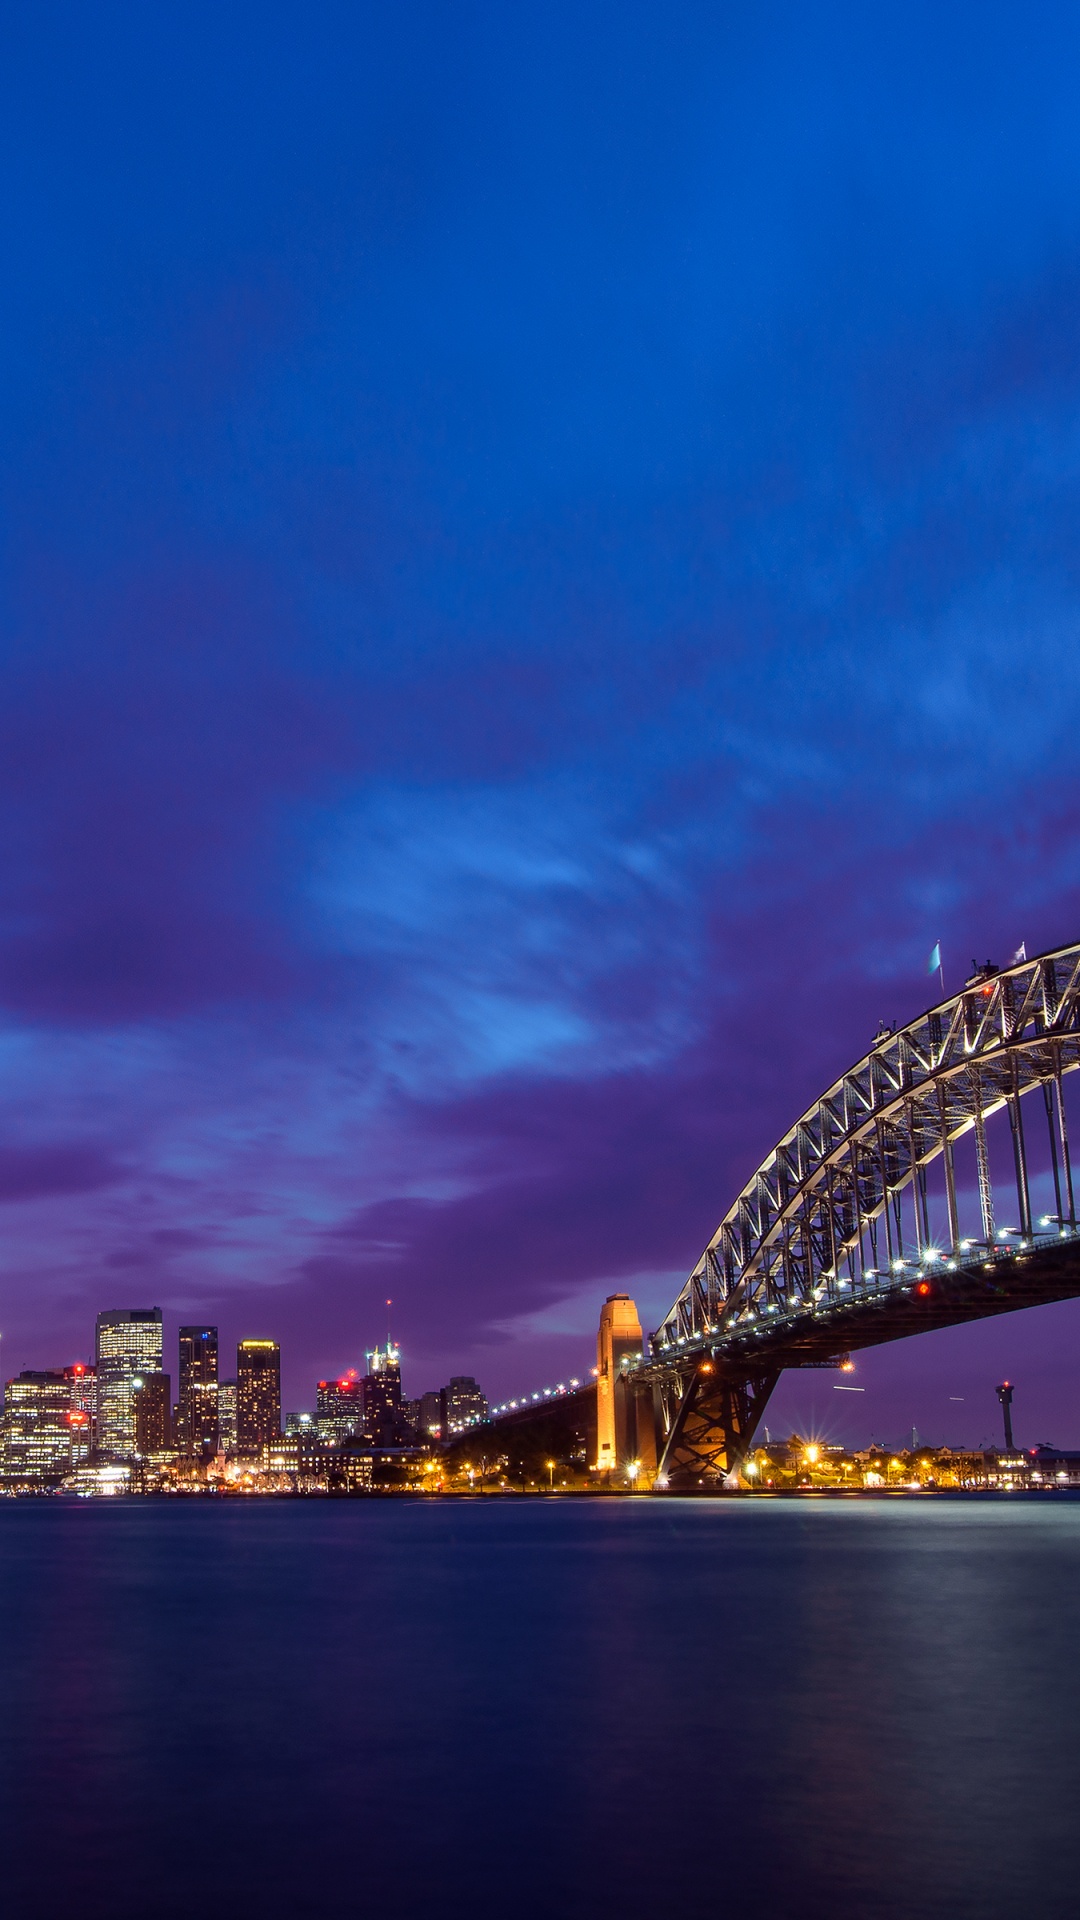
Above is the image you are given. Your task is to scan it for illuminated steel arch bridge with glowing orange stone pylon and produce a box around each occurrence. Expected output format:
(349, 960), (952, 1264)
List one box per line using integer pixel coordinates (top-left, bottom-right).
(486, 945), (1080, 1490)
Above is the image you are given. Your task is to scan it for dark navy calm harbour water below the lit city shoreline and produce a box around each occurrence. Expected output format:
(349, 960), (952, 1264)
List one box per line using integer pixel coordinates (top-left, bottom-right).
(0, 1496), (1080, 1920)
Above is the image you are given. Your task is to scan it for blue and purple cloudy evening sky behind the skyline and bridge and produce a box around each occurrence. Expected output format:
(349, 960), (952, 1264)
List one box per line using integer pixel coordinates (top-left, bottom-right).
(0, 0), (1080, 1444)
